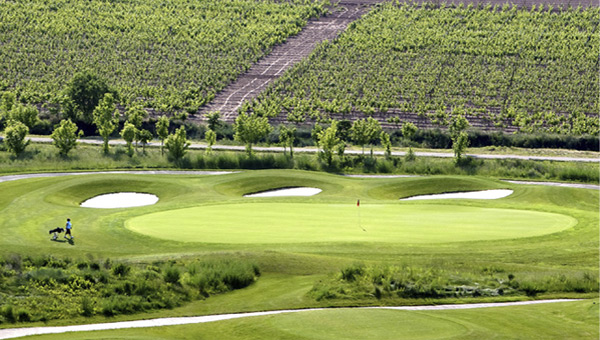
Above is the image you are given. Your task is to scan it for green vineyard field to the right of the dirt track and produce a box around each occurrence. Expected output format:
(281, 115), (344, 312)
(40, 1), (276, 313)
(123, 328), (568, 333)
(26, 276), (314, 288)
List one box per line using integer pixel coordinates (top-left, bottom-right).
(251, 2), (600, 135)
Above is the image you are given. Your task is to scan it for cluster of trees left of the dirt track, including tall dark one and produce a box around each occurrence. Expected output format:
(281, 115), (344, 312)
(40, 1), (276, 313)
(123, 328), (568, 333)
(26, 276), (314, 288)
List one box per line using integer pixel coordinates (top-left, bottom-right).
(0, 84), (189, 159)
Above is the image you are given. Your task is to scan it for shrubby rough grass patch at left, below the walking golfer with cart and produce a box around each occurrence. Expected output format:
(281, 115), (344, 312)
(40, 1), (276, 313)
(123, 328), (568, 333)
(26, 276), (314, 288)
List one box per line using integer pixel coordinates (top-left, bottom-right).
(0, 255), (260, 324)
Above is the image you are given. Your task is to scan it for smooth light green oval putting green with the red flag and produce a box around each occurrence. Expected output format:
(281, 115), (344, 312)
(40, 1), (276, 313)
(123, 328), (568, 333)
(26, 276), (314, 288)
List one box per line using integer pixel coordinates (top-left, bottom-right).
(125, 203), (577, 244)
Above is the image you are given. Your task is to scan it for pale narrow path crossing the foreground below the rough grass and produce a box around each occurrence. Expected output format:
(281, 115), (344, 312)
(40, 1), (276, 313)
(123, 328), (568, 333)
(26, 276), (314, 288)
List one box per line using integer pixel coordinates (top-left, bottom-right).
(0, 299), (580, 339)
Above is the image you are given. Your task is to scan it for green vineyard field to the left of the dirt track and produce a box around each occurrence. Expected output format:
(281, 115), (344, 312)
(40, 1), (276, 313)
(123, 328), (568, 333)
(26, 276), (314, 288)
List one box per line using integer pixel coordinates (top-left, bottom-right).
(0, 0), (326, 112)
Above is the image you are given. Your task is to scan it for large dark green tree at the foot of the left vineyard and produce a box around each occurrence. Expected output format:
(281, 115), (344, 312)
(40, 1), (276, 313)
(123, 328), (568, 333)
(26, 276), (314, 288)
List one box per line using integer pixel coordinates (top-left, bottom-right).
(66, 70), (110, 123)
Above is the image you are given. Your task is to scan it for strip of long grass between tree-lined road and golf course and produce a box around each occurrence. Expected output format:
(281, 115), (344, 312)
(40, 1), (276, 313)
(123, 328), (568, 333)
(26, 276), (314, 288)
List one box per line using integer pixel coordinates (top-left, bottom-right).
(0, 144), (600, 183)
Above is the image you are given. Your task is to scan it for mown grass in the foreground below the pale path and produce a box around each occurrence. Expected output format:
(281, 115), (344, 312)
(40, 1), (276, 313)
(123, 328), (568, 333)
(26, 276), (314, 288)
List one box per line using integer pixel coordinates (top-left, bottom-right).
(21, 300), (599, 340)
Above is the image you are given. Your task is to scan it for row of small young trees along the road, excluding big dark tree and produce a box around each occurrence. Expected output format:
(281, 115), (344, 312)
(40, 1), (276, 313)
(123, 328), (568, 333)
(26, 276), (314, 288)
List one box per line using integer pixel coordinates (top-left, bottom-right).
(0, 93), (469, 166)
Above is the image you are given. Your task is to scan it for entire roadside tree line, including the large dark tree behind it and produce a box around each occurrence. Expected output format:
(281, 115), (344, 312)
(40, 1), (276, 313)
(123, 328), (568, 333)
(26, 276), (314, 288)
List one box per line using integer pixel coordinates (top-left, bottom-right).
(0, 71), (476, 166)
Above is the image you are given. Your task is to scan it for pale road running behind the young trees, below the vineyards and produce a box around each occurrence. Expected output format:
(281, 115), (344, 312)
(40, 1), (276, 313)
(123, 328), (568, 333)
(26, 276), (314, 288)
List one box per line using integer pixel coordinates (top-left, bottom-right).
(27, 137), (600, 163)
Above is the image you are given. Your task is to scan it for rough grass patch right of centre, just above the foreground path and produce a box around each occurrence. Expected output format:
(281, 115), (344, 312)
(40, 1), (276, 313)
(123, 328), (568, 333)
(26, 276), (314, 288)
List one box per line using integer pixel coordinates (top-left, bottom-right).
(309, 264), (598, 301)
